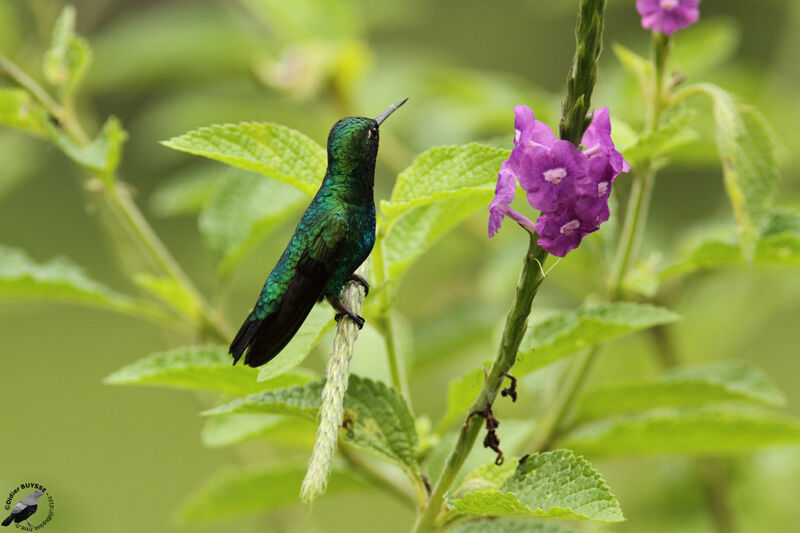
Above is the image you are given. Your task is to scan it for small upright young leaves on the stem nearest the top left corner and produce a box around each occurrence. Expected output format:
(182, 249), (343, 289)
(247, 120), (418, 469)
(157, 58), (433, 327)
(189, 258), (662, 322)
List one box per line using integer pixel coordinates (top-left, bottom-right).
(44, 5), (92, 93)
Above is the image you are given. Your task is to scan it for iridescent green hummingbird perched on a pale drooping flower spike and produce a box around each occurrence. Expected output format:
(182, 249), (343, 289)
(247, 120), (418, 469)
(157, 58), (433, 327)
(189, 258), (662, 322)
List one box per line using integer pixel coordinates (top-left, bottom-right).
(229, 98), (408, 367)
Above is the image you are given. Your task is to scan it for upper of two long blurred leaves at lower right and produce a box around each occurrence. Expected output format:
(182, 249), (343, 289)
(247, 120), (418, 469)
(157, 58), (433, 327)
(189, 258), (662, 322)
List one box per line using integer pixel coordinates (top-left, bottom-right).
(576, 361), (786, 420)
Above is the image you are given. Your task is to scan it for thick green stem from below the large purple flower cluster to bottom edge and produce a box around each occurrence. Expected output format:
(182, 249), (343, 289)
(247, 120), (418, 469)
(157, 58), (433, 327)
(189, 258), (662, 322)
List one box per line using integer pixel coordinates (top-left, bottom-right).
(414, 233), (547, 532)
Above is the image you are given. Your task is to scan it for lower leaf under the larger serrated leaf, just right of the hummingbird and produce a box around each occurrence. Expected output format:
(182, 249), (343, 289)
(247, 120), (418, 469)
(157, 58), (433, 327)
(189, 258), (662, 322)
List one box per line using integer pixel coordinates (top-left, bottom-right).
(382, 190), (493, 280)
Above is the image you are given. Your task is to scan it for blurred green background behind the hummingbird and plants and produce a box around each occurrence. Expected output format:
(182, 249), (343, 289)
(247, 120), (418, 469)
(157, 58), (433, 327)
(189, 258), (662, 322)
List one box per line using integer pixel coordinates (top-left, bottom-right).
(0, 0), (800, 533)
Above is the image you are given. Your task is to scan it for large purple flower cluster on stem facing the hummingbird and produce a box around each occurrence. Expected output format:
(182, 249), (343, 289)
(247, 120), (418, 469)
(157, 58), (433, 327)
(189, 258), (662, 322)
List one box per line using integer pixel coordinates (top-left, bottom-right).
(489, 106), (630, 257)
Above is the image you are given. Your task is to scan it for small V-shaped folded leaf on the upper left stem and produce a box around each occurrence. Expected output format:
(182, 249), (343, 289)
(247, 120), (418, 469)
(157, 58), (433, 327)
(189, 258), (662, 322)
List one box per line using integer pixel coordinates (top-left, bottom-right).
(51, 117), (128, 176)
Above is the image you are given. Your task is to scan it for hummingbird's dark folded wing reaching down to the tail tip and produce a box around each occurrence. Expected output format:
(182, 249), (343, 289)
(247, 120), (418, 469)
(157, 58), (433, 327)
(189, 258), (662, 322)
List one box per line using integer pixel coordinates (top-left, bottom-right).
(230, 212), (348, 367)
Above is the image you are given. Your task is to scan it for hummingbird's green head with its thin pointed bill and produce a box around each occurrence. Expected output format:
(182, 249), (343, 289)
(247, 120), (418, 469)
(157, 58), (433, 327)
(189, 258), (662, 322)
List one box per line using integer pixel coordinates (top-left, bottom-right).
(328, 98), (408, 181)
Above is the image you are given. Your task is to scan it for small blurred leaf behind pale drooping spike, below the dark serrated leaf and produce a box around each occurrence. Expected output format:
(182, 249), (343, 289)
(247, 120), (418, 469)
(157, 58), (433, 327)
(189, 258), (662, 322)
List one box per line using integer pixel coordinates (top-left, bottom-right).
(200, 415), (316, 450)
